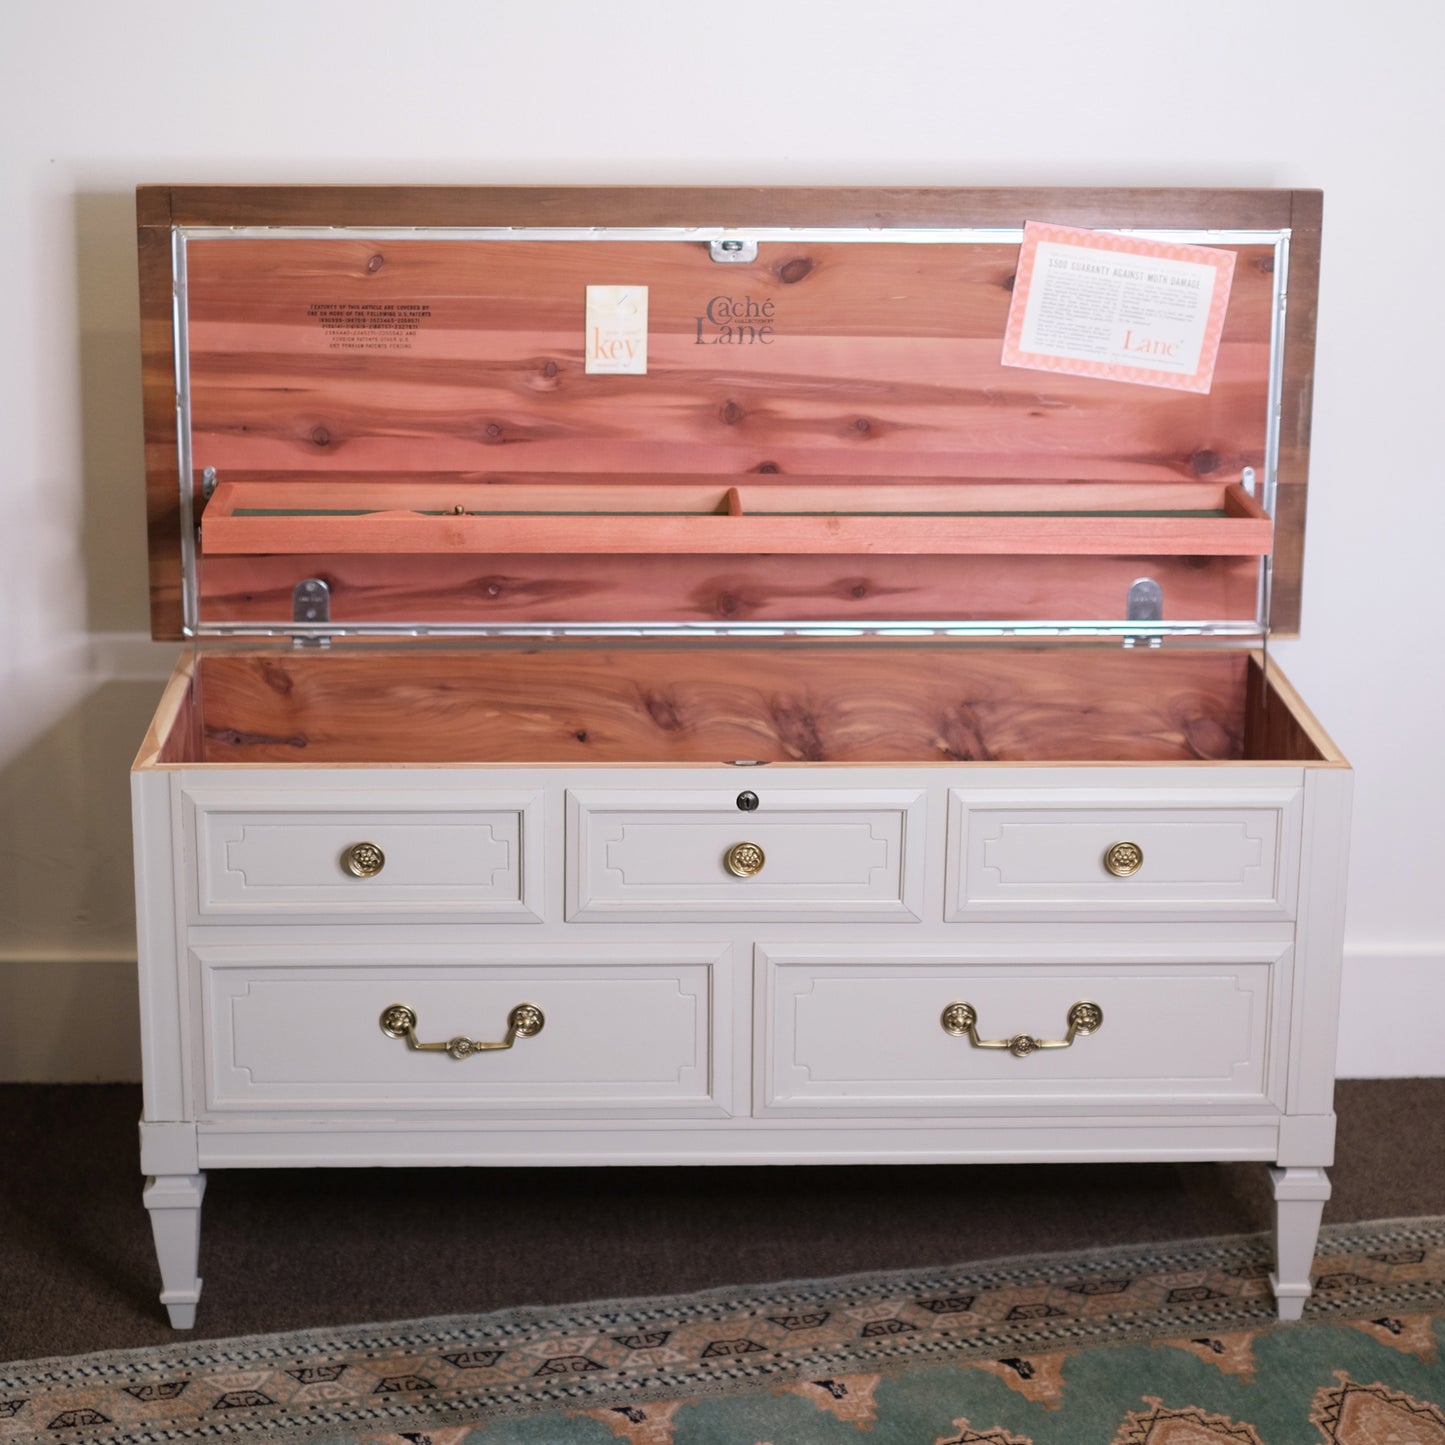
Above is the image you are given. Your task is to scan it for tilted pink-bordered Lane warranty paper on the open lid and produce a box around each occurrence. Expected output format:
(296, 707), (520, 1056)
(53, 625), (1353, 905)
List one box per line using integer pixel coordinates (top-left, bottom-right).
(1003, 221), (1234, 392)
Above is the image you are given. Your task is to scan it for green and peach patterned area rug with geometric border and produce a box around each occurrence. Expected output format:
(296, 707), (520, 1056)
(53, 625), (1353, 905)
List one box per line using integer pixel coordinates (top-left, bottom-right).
(0, 1218), (1445, 1445)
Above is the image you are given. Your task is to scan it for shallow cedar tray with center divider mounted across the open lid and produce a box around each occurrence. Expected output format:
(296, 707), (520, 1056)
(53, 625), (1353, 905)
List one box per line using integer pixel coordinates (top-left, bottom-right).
(201, 478), (1273, 556)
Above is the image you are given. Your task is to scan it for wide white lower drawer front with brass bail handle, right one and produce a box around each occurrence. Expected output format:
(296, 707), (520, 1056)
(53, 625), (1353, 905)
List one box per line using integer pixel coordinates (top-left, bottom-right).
(756, 944), (1289, 1114)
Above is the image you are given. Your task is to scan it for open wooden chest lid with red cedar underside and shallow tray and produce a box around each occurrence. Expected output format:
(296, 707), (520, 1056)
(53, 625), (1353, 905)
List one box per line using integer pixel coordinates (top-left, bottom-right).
(139, 186), (1319, 639)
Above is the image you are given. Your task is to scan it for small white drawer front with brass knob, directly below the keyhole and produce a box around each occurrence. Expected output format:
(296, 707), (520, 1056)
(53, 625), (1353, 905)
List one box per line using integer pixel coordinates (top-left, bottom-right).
(566, 789), (923, 920)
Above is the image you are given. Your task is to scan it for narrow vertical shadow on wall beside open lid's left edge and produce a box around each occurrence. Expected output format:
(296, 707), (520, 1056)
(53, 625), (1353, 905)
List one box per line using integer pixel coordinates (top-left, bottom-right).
(75, 192), (150, 638)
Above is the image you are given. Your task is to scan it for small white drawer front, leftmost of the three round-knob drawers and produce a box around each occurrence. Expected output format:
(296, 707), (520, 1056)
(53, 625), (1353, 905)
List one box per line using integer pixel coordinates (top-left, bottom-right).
(186, 789), (542, 923)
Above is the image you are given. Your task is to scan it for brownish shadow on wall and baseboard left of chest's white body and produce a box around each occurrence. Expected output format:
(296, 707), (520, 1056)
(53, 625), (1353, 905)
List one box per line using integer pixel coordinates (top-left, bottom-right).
(0, 682), (160, 1082)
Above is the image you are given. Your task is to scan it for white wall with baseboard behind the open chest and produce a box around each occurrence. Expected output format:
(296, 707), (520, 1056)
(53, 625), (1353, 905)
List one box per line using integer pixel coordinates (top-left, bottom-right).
(0, 0), (1445, 1078)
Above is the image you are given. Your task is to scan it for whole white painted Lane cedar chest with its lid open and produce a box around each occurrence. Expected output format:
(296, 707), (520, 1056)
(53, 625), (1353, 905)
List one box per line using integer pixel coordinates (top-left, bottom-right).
(133, 188), (1351, 1327)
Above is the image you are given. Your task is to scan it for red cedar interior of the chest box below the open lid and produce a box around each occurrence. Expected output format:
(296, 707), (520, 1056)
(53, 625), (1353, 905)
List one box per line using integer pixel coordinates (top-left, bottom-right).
(139, 642), (1340, 766)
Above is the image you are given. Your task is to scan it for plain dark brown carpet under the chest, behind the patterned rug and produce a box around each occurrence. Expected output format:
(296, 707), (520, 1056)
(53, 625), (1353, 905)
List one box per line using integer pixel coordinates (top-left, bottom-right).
(0, 1078), (1445, 1360)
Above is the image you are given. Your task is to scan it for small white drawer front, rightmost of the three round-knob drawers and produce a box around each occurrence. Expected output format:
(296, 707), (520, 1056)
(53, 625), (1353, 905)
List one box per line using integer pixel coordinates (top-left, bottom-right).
(946, 788), (1301, 919)
